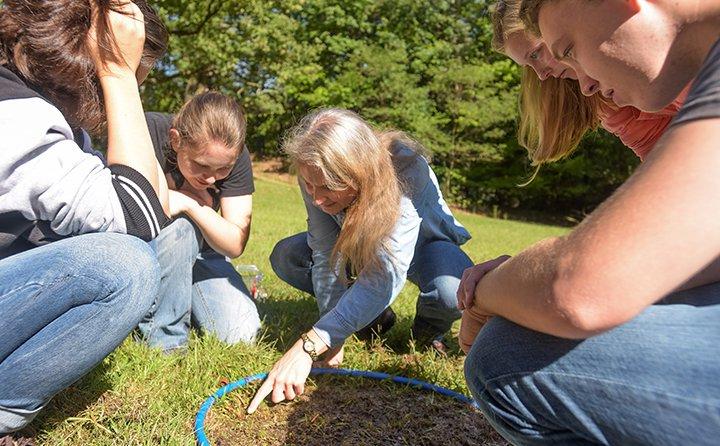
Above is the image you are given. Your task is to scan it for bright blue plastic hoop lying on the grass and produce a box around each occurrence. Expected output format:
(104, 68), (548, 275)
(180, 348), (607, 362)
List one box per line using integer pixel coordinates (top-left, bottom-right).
(195, 368), (478, 446)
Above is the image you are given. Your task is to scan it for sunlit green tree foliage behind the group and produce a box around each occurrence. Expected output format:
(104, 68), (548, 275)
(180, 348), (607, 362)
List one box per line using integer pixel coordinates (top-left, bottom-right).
(143, 0), (634, 216)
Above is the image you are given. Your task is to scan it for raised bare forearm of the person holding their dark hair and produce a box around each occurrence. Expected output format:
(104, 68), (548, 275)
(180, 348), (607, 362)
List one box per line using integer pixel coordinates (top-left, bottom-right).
(101, 75), (168, 211)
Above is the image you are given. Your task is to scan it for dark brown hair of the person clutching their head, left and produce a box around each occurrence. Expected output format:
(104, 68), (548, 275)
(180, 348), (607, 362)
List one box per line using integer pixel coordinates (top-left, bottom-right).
(0, 0), (167, 133)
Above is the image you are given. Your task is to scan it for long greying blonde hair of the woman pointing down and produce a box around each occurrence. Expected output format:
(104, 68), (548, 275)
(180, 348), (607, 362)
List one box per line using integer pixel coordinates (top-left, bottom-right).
(283, 108), (415, 280)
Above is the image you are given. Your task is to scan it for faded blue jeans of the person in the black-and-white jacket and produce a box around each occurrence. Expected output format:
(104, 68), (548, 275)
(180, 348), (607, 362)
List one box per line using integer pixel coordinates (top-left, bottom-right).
(0, 233), (160, 434)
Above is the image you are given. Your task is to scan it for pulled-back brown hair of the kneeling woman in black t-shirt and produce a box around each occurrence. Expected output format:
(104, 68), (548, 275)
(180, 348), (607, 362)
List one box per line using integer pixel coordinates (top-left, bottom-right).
(172, 91), (246, 154)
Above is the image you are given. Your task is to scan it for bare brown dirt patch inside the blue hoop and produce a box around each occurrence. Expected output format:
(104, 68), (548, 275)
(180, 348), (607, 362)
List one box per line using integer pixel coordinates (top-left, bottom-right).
(205, 376), (508, 446)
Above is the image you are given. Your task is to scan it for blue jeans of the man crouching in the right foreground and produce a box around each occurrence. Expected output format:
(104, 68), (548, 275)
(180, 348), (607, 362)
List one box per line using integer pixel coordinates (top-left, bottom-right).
(465, 283), (720, 445)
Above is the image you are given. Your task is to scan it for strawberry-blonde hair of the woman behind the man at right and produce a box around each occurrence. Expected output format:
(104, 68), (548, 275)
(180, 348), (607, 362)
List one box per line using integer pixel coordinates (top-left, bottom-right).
(492, 0), (610, 169)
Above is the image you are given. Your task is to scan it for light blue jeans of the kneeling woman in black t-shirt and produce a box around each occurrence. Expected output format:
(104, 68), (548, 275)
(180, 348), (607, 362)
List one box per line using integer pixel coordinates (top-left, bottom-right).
(138, 218), (260, 351)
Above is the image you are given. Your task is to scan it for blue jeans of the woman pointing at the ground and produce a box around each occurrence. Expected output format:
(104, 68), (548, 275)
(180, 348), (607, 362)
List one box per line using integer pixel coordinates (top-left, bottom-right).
(270, 232), (473, 339)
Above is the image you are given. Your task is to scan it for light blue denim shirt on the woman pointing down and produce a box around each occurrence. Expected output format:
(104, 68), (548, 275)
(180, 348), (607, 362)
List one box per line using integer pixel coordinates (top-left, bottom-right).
(300, 144), (470, 347)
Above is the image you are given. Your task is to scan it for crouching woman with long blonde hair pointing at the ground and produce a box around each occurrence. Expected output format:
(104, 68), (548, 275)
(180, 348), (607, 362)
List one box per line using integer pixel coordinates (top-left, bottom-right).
(248, 109), (472, 413)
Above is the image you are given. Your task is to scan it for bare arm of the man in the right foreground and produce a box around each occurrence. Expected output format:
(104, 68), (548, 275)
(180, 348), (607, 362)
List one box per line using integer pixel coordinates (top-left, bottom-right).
(461, 119), (720, 339)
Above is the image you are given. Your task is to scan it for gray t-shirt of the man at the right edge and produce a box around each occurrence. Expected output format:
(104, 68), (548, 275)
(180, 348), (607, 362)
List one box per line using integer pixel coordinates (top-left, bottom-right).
(670, 40), (720, 127)
